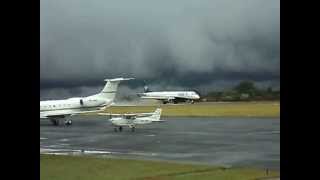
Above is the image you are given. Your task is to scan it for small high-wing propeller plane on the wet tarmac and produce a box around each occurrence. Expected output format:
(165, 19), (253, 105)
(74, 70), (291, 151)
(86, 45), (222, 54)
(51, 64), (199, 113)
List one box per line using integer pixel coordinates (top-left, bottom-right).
(99, 108), (164, 132)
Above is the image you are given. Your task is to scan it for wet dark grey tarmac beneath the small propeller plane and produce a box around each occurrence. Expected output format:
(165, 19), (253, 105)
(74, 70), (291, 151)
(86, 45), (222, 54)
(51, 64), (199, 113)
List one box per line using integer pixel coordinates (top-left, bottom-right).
(40, 116), (280, 170)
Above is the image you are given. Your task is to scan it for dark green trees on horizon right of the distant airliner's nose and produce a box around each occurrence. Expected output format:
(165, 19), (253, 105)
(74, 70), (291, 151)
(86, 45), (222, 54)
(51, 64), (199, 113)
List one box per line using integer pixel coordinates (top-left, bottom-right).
(202, 81), (280, 101)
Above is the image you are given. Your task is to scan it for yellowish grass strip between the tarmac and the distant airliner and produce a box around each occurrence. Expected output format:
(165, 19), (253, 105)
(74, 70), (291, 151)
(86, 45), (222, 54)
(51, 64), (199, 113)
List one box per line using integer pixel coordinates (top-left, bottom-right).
(90, 101), (280, 117)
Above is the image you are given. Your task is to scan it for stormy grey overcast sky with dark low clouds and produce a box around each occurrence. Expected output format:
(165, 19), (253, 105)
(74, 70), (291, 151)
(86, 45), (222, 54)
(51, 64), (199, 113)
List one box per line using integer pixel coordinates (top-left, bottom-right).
(40, 0), (280, 99)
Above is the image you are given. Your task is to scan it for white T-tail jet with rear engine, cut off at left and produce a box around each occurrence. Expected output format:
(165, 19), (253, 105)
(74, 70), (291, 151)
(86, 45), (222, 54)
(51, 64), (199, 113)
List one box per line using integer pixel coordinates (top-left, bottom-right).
(40, 78), (133, 125)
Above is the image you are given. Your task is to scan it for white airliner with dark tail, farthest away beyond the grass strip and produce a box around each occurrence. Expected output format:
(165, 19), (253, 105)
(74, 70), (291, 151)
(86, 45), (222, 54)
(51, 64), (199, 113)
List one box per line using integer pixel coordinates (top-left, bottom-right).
(137, 86), (200, 104)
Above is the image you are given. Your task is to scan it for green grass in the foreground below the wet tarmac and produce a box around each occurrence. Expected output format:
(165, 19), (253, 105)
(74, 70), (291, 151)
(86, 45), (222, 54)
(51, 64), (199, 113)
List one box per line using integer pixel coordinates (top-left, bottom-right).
(40, 155), (279, 180)
